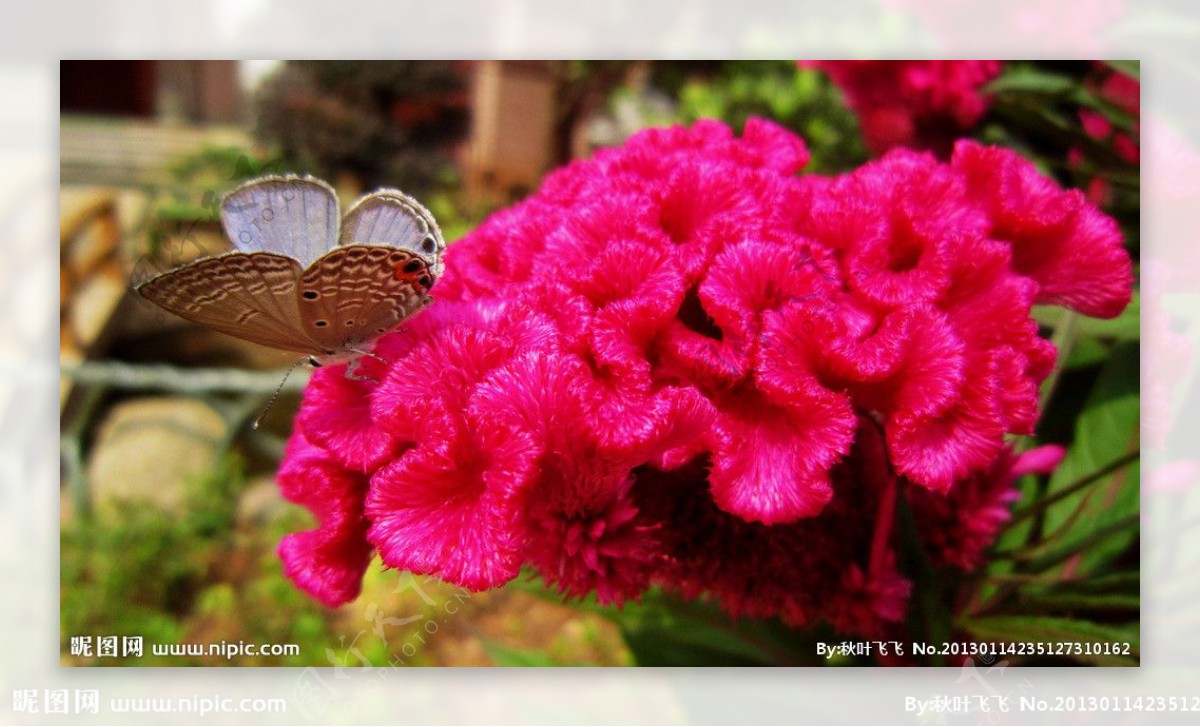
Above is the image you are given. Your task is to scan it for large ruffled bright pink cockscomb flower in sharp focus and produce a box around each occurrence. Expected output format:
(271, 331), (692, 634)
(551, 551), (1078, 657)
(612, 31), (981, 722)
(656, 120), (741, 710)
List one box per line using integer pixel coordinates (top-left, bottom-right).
(281, 119), (1132, 635)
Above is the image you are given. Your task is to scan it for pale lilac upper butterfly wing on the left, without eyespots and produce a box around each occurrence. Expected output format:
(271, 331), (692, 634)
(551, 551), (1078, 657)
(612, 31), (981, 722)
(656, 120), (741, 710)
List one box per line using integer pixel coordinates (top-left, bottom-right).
(221, 175), (338, 269)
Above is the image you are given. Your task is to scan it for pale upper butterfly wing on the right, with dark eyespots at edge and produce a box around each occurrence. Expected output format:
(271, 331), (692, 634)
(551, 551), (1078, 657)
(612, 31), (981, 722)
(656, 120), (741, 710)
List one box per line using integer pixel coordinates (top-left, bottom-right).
(337, 190), (446, 280)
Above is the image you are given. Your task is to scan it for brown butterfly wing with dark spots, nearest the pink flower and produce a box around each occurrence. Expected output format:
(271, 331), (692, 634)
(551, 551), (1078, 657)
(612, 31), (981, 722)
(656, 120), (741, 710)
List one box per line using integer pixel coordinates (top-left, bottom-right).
(298, 245), (433, 350)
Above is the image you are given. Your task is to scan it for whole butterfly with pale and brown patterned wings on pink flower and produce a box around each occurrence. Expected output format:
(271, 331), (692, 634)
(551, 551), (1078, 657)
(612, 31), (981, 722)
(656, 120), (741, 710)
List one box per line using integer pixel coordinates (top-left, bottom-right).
(136, 175), (445, 374)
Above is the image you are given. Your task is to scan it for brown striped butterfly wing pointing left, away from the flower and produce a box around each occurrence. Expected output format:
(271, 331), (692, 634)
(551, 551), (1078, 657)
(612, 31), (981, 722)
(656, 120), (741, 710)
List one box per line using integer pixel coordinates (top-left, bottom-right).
(137, 252), (323, 354)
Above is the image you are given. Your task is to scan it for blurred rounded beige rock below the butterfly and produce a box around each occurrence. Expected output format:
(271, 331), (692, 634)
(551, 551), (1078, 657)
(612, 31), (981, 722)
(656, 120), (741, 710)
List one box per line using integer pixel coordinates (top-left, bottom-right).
(88, 397), (228, 511)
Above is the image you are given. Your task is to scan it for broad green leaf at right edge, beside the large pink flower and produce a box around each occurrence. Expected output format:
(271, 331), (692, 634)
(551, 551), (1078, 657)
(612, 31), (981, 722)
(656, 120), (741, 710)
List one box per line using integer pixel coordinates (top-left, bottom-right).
(1043, 342), (1140, 575)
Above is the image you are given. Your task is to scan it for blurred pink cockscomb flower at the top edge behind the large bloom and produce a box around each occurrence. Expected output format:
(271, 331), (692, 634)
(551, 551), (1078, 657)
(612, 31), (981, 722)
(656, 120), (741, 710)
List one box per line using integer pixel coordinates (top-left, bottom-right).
(800, 60), (1000, 157)
